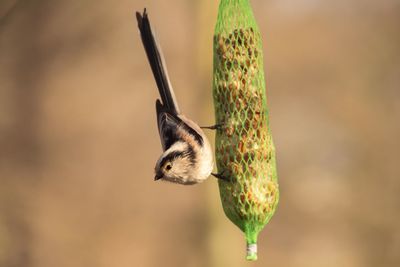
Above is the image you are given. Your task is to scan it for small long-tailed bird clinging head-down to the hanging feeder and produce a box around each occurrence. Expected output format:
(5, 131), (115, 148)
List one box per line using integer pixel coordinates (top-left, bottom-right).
(136, 9), (220, 185)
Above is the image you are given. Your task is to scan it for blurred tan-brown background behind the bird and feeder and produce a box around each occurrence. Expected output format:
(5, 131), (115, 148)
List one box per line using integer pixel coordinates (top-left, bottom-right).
(0, 0), (400, 267)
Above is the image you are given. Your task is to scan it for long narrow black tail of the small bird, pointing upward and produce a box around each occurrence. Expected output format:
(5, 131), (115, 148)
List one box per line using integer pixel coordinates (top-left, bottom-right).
(136, 9), (179, 114)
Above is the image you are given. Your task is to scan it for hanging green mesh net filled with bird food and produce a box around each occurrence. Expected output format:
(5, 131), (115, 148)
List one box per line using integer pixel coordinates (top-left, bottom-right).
(213, 0), (279, 260)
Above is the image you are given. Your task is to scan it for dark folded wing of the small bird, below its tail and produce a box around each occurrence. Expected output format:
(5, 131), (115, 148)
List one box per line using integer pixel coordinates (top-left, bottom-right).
(156, 99), (204, 151)
